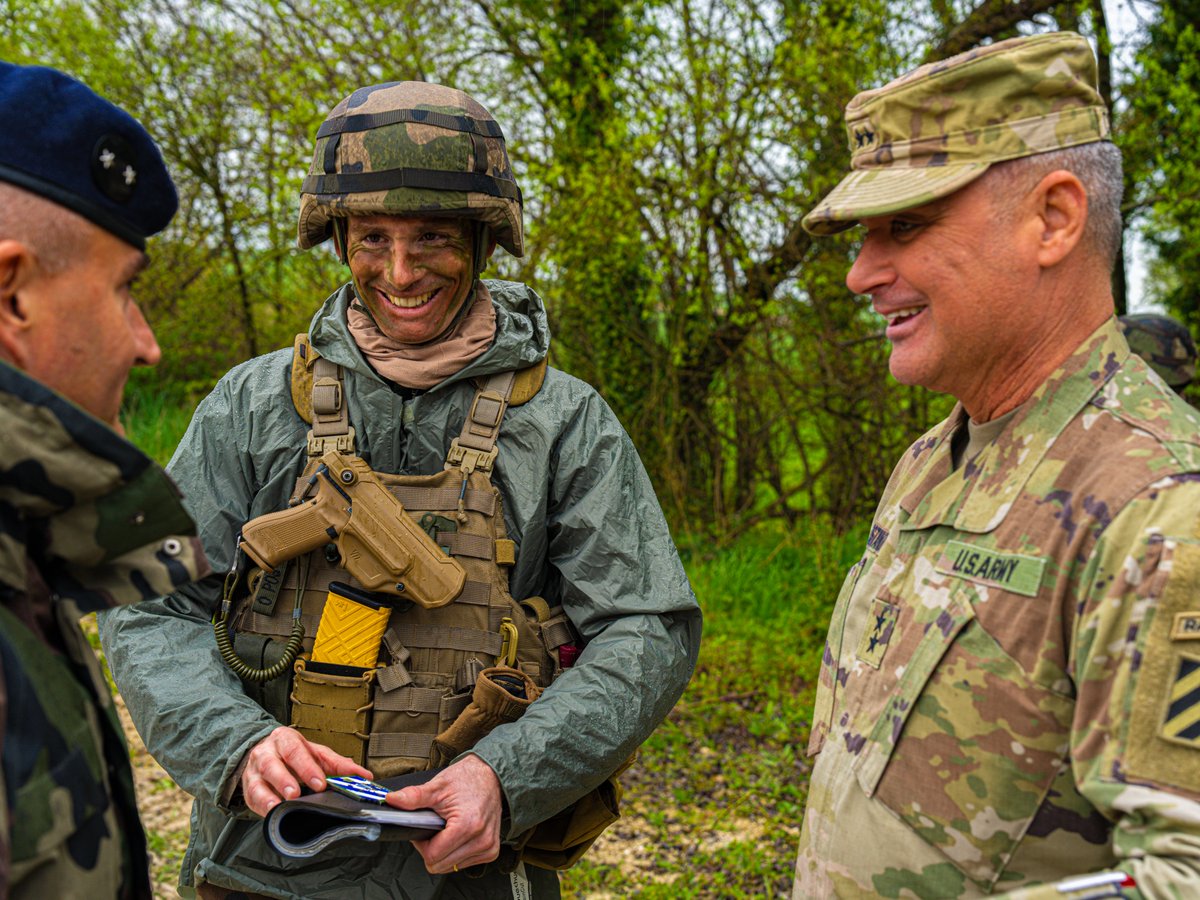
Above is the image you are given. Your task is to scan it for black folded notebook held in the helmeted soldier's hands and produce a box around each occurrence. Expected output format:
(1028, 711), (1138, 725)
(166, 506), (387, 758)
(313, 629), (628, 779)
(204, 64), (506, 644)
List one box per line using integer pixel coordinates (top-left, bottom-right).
(263, 769), (445, 858)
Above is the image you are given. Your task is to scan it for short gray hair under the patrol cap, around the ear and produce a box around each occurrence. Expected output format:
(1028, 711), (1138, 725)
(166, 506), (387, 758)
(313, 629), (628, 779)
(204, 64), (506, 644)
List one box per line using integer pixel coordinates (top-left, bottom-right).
(988, 140), (1124, 271)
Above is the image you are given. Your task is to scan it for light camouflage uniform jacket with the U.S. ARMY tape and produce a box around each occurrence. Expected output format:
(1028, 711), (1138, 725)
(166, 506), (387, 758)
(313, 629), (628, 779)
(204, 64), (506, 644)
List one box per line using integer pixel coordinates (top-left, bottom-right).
(794, 320), (1200, 898)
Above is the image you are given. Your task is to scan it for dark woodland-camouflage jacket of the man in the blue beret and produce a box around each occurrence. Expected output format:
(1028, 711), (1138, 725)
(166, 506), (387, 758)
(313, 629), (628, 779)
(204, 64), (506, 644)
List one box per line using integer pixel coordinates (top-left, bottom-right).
(0, 364), (208, 900)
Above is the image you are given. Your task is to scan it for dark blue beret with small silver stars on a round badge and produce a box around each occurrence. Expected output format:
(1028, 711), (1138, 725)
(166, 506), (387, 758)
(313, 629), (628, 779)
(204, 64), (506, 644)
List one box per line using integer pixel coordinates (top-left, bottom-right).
(0, 62), (179, 250)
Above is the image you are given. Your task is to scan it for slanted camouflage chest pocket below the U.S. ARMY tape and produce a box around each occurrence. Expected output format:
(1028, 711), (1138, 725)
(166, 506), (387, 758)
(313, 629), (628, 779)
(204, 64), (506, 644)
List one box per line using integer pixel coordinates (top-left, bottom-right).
(857, 592), (1073, 889)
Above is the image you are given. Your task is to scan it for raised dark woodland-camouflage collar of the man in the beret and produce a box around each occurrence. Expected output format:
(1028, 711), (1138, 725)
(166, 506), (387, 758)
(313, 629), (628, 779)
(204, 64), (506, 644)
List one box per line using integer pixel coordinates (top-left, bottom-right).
(0, 362), (209, 612)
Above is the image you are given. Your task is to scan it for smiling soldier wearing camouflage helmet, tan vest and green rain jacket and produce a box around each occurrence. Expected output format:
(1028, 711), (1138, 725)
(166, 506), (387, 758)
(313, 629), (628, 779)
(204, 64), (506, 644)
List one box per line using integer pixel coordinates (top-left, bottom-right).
(101, 82), (700, 900)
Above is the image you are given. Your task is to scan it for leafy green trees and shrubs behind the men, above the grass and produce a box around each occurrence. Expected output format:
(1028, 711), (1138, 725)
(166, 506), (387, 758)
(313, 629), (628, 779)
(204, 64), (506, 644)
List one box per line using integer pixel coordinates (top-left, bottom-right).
(9, 0), (1200, 541)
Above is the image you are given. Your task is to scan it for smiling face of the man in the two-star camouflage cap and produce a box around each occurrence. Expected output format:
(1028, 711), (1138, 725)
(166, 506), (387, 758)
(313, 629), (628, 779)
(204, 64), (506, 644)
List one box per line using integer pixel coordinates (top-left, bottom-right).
(846, 175), (1046, 414)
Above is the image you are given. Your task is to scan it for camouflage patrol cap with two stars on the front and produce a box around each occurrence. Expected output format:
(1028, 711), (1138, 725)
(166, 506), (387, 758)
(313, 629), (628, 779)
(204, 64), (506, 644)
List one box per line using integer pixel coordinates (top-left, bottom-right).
(803, 31), (1109, 234)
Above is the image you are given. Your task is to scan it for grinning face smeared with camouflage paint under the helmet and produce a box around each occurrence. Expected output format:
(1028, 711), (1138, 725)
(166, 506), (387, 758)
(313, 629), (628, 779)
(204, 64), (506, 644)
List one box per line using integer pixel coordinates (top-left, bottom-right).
(346, 215), (474, 344)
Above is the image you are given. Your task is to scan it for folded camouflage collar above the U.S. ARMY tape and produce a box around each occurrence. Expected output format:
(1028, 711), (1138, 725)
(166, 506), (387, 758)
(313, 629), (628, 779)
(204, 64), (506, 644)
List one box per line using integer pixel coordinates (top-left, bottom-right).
(900, 318), (1129, 534)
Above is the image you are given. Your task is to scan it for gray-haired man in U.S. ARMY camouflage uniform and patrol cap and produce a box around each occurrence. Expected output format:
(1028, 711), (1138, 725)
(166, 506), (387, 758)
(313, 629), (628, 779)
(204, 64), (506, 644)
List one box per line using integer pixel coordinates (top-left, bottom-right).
(794, 34), (1200, 898)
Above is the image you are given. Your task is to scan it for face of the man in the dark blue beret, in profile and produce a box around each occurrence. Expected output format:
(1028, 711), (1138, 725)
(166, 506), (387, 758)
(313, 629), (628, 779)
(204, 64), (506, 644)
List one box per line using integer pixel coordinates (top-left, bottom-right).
(6, 221), (162, 431)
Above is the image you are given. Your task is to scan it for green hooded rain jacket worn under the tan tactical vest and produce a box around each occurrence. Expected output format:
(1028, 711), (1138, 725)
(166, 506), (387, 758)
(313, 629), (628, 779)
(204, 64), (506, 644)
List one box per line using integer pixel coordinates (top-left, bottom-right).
(101, 282), (701, 900)
